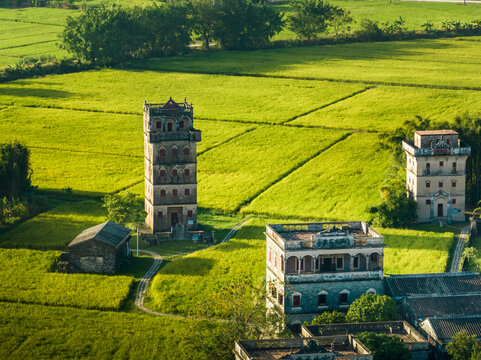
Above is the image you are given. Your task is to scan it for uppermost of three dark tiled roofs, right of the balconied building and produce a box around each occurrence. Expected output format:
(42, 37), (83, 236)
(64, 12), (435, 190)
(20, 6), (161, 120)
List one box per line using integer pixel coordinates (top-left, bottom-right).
(385, 273), (481, 298)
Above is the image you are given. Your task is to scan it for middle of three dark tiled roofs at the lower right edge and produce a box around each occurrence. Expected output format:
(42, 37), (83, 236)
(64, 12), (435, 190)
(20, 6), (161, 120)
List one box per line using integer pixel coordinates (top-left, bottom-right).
(406, 293), (481, 319)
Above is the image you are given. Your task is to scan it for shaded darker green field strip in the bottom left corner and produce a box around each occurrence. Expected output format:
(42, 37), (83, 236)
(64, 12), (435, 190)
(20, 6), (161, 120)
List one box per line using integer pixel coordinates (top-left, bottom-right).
(0, 303), (199, 360)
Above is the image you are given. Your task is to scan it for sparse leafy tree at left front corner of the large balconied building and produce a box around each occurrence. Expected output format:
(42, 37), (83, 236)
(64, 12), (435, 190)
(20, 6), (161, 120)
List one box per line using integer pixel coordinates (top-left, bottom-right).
(189, 280), (287, 359)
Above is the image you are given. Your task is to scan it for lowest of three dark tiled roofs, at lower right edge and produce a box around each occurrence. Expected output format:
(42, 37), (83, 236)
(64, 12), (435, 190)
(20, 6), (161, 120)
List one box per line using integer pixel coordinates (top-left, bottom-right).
(429, 315), (481, 340)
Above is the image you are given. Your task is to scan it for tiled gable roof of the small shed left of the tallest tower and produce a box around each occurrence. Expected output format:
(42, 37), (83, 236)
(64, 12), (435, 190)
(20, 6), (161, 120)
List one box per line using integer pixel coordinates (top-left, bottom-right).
(68, 221), (131, 247)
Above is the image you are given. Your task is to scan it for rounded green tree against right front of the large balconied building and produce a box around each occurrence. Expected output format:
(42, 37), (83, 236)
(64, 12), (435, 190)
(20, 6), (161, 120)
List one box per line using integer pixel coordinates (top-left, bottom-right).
(346, 294), (398, 322)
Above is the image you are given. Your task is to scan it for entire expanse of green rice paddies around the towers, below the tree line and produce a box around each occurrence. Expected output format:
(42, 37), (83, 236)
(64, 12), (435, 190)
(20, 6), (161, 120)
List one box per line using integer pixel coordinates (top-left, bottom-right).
(0, 2), (481, 359)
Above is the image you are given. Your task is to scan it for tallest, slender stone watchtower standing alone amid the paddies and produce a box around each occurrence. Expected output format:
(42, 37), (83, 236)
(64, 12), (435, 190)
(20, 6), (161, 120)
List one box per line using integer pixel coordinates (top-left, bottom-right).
(144, 98), (201, 238)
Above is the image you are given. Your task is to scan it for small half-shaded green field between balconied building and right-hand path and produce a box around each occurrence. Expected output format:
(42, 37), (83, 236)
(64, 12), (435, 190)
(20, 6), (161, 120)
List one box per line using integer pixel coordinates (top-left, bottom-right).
(379, 229), (454, 275)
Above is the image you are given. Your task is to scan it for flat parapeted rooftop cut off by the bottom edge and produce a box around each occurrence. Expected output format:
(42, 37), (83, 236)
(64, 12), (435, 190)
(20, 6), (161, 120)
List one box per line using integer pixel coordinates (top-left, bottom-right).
(235, 335), (372, 360)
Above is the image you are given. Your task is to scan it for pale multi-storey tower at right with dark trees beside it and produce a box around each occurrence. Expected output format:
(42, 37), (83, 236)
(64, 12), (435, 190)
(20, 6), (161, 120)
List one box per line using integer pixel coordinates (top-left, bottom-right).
(403, 130), (471, 224)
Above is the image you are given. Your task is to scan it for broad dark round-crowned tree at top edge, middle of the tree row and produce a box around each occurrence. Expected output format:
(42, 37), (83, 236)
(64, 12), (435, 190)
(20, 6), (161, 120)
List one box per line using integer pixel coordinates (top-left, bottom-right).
(213, 0), (284, 50)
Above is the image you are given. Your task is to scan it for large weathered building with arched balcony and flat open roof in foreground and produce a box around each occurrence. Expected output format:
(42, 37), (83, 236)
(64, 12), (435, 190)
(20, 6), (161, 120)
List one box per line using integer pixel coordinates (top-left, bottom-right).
(265, 221), (384, 327)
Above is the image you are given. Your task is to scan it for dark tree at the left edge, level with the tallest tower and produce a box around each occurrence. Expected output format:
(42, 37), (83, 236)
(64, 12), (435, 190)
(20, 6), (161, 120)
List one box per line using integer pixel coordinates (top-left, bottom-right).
(0, 142), (32, 198)
